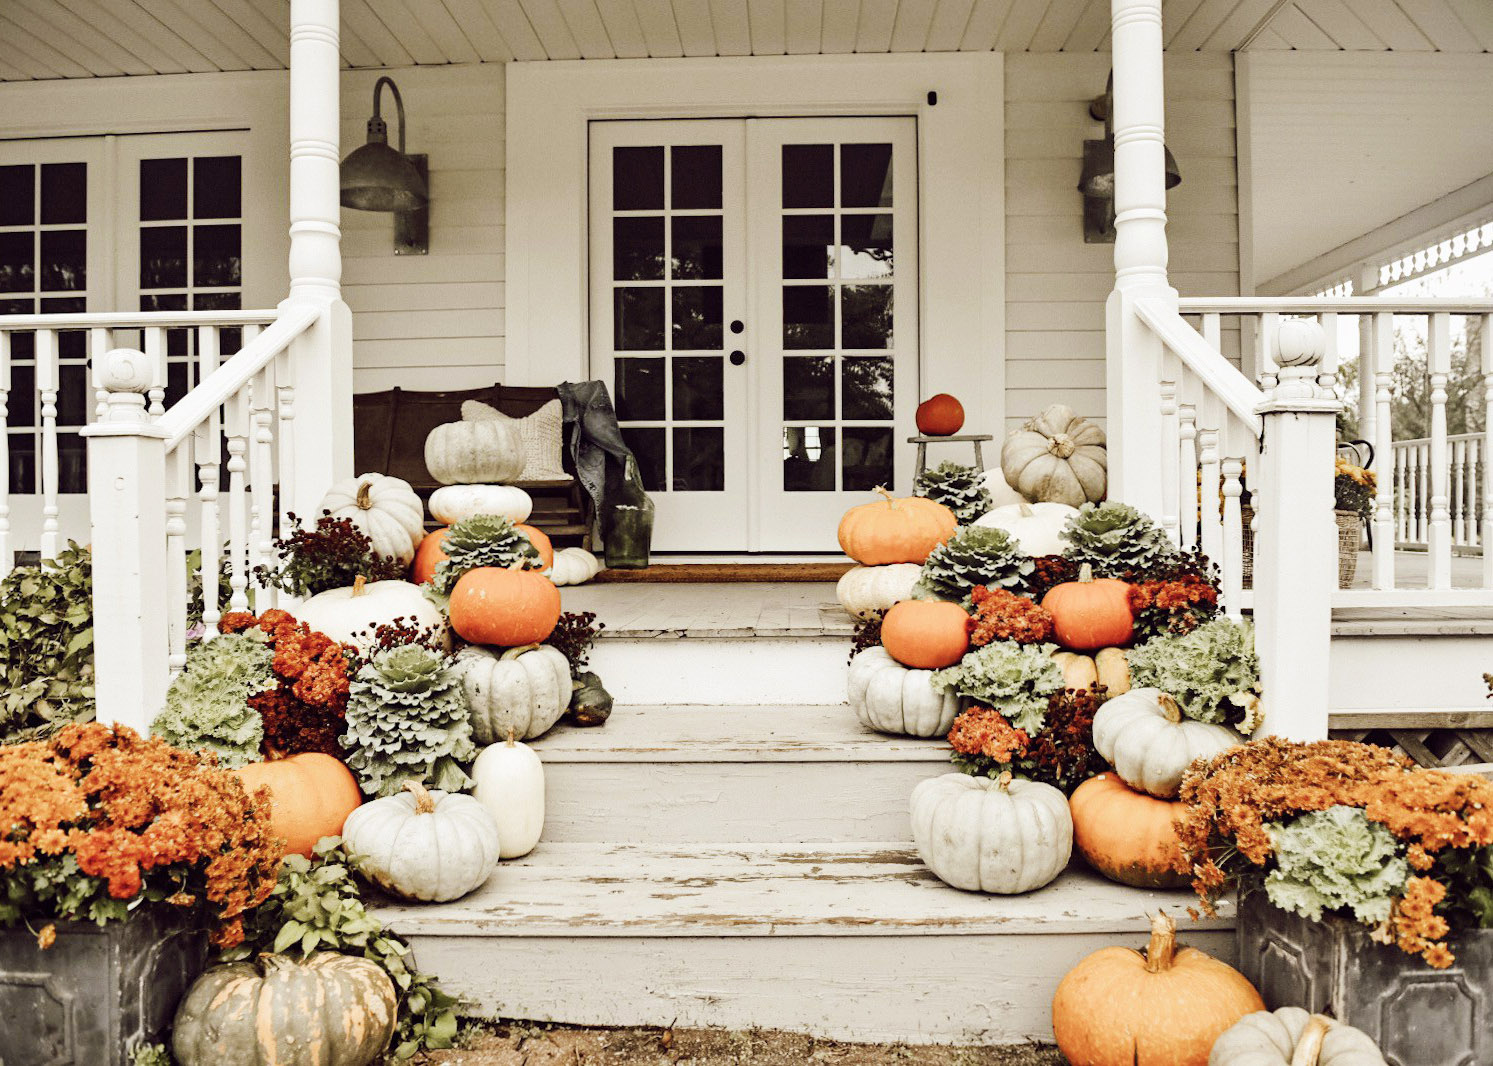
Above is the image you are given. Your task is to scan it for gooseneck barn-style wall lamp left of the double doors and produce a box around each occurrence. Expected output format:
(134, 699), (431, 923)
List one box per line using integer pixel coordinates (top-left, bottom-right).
(342, 78), (430, 255)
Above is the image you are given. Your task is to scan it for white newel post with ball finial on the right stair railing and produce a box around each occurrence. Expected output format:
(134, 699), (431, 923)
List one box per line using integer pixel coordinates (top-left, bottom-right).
(1254, 321), (1342, 741)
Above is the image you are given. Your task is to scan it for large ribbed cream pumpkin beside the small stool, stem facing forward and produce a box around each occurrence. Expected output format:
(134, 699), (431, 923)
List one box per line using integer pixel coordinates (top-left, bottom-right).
(1000, 403), (1108, 508)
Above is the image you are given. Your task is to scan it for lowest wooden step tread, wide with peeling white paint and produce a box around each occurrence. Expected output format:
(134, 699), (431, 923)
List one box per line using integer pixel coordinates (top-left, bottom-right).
(378, 842), (1233, 938)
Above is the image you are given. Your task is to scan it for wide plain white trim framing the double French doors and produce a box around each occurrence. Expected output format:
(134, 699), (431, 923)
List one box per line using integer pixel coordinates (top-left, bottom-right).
(505, 52), (1006, 434)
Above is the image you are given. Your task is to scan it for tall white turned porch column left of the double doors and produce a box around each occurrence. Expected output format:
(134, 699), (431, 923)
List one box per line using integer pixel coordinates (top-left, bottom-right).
(281, 0), (352, 518)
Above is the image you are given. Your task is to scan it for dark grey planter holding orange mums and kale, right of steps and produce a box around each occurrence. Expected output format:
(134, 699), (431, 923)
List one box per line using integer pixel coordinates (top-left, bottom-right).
(1236, 891), (1493, 1066)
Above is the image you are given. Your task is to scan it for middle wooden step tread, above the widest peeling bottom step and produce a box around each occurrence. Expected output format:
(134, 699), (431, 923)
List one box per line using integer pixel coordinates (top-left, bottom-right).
(530, 705), (950, 764)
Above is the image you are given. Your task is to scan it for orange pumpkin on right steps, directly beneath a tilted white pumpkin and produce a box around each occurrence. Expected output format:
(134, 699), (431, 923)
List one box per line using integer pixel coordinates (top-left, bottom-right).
(1067, 773), (1188, 888)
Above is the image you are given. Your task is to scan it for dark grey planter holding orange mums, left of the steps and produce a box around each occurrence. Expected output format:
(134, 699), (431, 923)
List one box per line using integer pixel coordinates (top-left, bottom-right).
(0, 908), (208, 1066)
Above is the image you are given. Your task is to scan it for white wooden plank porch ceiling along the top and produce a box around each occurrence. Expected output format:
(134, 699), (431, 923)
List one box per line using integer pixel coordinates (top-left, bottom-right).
(0, 0), (1493, 81)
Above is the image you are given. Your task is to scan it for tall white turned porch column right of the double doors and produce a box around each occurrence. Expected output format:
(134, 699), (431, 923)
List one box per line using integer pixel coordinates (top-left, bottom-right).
(1106, 0), (1176, 515)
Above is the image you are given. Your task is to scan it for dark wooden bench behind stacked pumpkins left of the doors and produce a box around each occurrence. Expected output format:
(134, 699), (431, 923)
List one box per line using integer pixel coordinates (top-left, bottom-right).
(352, 385), (591, 548)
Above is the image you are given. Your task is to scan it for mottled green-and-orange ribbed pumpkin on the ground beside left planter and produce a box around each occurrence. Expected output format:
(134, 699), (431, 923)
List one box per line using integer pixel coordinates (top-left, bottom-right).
(172, 951), (399, 1066)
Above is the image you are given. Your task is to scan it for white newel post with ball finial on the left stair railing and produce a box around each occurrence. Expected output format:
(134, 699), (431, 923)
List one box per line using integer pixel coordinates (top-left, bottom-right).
(82, 348), (170, 733)
